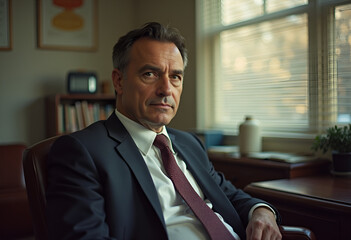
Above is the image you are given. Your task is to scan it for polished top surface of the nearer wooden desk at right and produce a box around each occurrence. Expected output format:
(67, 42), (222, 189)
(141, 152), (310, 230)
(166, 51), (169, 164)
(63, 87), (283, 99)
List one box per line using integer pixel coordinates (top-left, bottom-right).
(252, 175), (351, 207)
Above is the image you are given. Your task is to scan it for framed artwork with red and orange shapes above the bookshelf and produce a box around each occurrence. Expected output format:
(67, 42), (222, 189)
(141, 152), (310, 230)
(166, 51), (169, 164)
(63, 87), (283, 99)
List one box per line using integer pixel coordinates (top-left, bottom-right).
(37, 0), (97, 51)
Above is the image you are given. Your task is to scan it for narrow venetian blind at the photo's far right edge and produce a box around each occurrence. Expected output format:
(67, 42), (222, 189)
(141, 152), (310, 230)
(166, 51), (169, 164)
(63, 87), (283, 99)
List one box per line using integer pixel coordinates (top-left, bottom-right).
(317, 0), (351, 131)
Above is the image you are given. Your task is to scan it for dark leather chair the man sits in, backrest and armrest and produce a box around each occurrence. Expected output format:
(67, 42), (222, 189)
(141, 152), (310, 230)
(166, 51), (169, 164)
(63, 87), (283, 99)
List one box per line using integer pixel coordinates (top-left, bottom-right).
(23, 137), (315, 240)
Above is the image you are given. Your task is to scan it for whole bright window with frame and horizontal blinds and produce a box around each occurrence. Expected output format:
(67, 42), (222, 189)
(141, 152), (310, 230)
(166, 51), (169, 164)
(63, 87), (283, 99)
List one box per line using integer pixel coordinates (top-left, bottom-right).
(198, 0), (351, 136)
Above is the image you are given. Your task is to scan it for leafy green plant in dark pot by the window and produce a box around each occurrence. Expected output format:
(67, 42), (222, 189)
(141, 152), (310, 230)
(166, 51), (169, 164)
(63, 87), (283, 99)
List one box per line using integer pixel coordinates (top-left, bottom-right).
(312, 124), (351, 176)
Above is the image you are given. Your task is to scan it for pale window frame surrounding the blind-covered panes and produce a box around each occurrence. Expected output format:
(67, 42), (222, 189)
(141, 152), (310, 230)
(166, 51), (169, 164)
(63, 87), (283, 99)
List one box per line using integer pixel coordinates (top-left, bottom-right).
(196, 0), (349, 142)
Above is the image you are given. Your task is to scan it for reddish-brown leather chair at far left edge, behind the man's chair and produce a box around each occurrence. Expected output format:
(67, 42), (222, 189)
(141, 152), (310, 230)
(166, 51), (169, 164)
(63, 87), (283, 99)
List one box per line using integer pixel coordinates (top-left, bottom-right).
(0, 144), (33, 239)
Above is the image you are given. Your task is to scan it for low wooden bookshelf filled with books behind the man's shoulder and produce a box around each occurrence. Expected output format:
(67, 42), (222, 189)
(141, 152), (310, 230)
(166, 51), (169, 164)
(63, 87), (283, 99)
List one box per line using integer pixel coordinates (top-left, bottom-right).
(45, 94), (115, 137)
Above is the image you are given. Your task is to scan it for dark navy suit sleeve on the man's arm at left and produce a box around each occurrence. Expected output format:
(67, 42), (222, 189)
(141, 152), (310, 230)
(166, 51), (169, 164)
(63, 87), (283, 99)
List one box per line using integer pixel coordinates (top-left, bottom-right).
(46, 136), (118, 239)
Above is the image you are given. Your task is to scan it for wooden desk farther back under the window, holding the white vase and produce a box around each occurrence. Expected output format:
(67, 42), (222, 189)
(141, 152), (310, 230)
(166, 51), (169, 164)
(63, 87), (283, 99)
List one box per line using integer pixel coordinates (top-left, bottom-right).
(209, 154), (330, 188)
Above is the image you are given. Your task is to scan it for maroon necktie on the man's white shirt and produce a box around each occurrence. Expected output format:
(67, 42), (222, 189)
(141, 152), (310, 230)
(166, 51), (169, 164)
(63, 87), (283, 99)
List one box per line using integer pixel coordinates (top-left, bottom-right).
(154, 134), (235, 240)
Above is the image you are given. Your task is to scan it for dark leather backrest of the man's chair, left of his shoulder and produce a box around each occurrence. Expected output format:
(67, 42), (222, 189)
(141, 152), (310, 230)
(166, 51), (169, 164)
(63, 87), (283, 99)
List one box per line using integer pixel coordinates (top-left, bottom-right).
(23, 136), (57, 240)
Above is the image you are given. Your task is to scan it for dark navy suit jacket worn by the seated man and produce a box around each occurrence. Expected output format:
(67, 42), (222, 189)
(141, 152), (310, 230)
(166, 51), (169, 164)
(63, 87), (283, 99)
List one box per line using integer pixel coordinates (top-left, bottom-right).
(46, 113), (280, 240)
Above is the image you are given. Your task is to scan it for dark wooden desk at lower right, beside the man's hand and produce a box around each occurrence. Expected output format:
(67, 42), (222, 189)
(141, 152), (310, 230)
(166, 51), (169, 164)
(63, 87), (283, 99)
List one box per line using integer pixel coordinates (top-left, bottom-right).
(245, 175), (351, 240)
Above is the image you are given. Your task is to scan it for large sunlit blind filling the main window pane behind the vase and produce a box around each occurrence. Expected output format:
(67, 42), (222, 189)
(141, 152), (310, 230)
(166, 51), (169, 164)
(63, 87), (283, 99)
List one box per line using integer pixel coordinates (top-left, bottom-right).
(215, 15), (309, 131)
